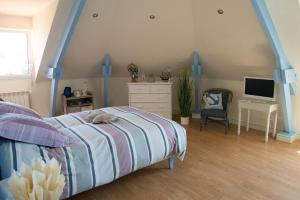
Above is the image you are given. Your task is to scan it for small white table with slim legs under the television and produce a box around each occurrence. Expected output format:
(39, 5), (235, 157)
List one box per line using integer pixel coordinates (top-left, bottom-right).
(237, 100), (278, 142)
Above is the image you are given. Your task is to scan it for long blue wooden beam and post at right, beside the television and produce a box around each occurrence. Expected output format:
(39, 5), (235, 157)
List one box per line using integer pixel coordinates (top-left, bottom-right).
(252, 0), (297, 142)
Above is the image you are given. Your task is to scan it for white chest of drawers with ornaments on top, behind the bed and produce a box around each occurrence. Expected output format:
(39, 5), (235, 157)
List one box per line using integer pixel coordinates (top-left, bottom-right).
(128, 82), (172, 119)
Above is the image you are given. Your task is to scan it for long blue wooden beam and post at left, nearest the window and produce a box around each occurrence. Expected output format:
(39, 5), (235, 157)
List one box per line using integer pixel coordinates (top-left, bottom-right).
(46, 0), (85, 117)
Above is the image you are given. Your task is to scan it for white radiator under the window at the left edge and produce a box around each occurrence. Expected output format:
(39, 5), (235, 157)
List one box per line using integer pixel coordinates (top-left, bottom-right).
(0, 91), (30, 108)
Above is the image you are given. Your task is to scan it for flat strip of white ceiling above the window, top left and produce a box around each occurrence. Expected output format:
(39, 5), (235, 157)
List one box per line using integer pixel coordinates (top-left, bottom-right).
(0, 0), (53, 16)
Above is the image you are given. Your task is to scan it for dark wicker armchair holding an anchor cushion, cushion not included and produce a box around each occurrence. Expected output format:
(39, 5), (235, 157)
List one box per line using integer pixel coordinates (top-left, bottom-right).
(200, 88), (233, 134)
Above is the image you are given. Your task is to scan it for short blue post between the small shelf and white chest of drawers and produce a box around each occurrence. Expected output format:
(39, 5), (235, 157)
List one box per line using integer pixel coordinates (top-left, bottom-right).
(102, 54), (111, 107)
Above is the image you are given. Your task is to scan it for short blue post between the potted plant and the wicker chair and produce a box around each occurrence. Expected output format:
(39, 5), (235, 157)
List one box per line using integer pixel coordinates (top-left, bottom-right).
(192, 52), (201, 118)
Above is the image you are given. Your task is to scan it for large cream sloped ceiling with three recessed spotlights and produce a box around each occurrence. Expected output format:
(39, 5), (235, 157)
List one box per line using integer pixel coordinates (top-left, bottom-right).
(41, 0), (275, 80)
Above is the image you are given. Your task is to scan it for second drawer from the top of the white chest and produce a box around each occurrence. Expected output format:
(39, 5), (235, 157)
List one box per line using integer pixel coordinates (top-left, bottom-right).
(129, 94), (170, 103)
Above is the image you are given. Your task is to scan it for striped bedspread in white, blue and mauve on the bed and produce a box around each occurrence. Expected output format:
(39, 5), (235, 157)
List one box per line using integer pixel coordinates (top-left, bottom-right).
(0, 107), (186, 198)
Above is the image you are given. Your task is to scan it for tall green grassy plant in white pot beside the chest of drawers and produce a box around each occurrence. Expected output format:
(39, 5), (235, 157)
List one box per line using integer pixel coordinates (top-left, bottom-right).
(177, 70), (192, 125)
